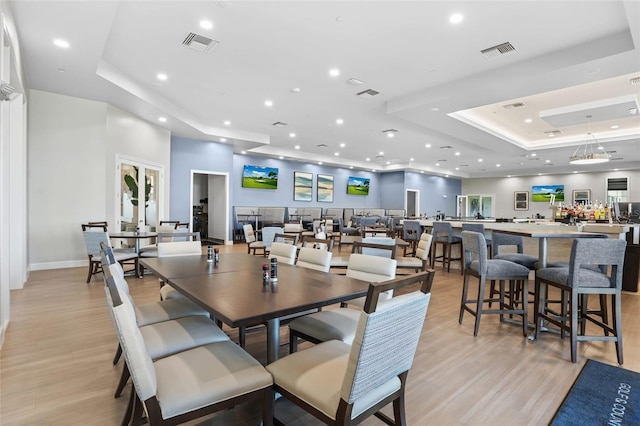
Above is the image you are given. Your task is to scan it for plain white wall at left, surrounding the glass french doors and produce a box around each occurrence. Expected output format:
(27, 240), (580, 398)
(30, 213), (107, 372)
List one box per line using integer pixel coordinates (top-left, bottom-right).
(28, 90), (170, 270)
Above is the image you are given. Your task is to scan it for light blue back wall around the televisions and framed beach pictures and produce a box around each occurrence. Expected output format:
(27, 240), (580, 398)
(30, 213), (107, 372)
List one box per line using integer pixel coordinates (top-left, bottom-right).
(169, 136), (462, 238)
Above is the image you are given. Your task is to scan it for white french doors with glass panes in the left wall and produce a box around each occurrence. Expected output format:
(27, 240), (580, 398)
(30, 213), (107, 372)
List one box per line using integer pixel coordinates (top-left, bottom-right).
(115, 156), (164, 231)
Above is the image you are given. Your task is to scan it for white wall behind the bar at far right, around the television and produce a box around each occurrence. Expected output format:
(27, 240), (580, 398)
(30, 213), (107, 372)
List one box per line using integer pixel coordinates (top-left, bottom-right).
(462, 170), (640, 218)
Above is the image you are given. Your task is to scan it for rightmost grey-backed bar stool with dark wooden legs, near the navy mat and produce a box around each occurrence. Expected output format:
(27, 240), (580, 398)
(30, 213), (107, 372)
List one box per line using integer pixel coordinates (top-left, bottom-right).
(535, 238), (627, 364)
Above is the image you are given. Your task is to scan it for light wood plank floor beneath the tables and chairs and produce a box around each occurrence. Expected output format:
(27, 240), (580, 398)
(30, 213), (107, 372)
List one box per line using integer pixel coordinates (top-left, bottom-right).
(0, 244), (640, 426)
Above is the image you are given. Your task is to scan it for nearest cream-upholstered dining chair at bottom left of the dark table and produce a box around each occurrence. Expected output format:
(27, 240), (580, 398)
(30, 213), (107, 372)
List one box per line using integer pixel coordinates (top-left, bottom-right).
(105, 268), (273, 426)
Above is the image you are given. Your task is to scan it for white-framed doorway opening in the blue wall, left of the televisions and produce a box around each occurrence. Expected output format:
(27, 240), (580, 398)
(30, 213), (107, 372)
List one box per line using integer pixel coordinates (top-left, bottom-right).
(190, 170), (233, 244)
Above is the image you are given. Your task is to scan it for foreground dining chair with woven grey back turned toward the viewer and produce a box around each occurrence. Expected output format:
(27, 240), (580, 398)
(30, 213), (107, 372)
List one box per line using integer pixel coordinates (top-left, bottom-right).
(267, 271), (433, 425)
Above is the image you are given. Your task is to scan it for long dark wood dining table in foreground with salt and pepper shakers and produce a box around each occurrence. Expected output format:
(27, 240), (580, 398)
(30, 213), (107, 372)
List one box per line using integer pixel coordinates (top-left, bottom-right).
(141, 253), (369, 363)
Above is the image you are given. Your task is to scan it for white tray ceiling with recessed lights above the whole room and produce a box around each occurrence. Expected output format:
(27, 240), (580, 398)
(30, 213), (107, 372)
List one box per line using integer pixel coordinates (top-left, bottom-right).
(8, 0), (640, 177)
